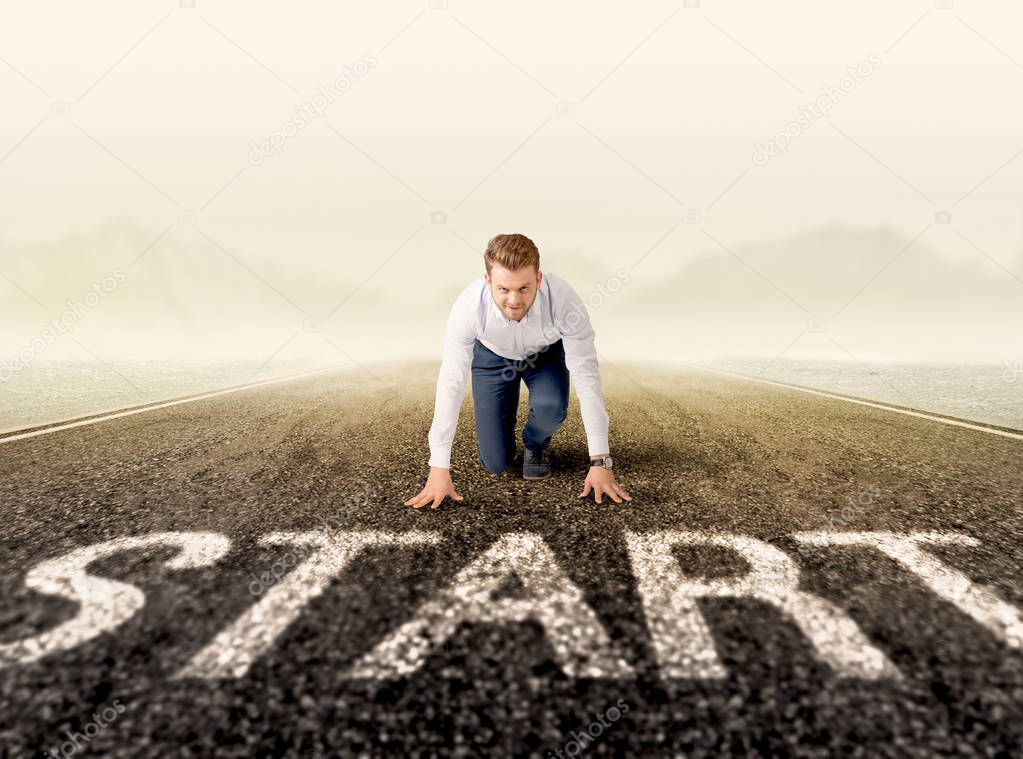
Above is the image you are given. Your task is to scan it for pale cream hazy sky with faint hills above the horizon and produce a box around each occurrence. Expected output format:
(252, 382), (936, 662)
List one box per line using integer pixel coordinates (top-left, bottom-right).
(0, 0), (1023, 372)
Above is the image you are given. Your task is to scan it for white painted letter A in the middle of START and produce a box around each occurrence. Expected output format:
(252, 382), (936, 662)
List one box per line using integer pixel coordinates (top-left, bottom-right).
(348, 533), (633, 679)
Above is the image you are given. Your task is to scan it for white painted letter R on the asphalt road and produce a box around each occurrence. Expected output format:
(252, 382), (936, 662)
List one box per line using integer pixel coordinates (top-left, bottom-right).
(625, 530), (900, 679)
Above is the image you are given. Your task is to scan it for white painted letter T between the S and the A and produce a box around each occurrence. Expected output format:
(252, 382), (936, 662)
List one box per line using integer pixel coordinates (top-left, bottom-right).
(175, 530), (440, 679)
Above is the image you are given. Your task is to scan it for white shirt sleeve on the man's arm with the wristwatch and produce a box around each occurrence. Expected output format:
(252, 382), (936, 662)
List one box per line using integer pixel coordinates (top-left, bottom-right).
(550, 277), (611, 456)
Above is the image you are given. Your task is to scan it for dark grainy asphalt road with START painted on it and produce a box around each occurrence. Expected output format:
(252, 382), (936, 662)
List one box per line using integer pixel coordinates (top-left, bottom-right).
(0, 362), (1023, 759)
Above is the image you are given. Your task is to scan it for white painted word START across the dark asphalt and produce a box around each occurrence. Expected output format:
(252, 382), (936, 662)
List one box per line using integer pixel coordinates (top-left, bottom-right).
(0, 530), (1023, 679)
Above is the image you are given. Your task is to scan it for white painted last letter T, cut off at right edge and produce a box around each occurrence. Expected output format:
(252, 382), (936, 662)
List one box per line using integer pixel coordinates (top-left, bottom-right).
(792, 532), (1023, 649)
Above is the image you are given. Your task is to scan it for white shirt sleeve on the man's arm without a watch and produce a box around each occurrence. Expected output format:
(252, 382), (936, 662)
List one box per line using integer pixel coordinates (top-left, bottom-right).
(429, 282), (480, 468)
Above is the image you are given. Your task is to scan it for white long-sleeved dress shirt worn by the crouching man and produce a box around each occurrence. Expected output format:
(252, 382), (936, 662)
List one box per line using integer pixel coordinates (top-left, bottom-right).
(430, 272), (611, 467)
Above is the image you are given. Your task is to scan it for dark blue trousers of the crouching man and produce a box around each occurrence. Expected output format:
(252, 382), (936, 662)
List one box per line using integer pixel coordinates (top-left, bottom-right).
(473, 340), (569, 474)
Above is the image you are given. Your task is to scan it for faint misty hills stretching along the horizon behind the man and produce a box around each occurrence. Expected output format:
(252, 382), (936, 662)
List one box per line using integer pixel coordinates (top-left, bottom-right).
(0, 220), (1023, 363)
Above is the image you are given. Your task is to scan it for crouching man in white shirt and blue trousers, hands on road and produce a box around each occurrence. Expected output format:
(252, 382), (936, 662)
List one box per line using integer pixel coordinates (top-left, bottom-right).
(405, 234), (632, 508)
